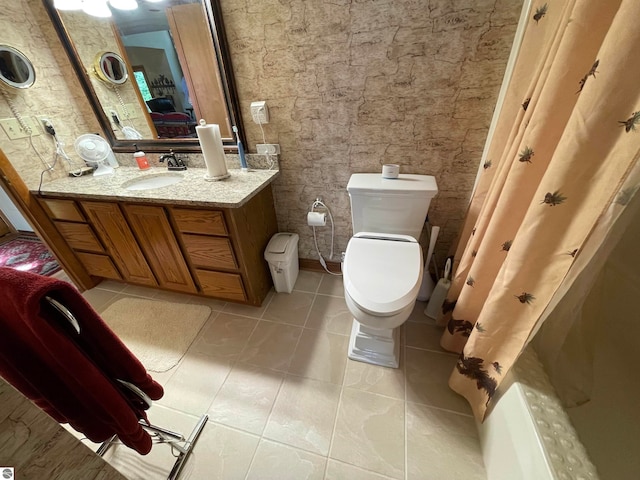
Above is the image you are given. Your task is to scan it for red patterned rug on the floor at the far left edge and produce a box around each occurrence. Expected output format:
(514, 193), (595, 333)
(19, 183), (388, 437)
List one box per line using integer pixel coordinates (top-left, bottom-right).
(0, 237), (60, 275)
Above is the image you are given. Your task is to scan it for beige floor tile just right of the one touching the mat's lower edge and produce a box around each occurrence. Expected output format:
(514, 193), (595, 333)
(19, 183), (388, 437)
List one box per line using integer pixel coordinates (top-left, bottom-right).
(209, 364), (284, 435)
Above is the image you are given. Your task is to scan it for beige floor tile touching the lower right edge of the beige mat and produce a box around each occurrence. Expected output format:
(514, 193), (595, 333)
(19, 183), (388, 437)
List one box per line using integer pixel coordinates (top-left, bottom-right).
(158, 353), (231, 415)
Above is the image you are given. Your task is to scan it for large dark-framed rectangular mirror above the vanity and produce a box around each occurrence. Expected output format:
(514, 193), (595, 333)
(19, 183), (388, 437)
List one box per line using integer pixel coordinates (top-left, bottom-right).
(42, 0), (246, 152)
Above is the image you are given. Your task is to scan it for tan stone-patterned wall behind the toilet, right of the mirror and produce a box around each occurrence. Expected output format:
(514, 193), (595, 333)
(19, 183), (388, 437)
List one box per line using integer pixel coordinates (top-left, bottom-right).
(221, 0), (522, 261)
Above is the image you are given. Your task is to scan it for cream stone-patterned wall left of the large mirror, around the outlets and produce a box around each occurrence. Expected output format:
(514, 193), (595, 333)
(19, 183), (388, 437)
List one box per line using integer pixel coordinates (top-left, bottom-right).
(0, 0), (100, 189)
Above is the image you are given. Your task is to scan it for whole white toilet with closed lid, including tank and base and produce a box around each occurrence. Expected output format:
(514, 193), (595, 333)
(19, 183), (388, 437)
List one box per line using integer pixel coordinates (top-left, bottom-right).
(342, 173), (438, 368)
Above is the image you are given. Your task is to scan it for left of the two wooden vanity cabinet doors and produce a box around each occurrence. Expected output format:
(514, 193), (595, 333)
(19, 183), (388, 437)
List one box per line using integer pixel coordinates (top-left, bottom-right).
(82, 202), (158, 287)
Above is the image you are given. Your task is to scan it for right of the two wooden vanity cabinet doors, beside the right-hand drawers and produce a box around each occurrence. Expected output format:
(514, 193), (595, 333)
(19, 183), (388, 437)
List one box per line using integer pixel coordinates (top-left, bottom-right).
(123, 205), (197, 293)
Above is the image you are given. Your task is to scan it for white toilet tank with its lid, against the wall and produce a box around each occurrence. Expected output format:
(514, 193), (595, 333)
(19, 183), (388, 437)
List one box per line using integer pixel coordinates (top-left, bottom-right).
(347, 173), (438, 240)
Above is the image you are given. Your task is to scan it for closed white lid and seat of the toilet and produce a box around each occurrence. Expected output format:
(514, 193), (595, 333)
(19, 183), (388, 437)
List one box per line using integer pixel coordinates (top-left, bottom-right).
(342, 233), (423, 316)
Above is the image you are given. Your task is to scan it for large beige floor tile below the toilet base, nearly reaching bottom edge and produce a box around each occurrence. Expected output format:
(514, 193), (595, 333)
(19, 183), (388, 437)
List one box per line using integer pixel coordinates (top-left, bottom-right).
(329, 388), (405, 478)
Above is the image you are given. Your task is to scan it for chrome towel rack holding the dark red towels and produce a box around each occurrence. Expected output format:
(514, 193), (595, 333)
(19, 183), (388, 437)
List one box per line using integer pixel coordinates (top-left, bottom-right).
(44, 295), (209, 480)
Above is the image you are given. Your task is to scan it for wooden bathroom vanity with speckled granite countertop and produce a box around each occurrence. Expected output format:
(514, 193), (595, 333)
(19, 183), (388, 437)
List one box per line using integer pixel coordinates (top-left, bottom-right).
(38, 167), (278, 305)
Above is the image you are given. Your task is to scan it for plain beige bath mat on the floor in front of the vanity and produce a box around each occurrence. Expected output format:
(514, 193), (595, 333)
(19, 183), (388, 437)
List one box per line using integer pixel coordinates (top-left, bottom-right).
(101, 298), (211, 373)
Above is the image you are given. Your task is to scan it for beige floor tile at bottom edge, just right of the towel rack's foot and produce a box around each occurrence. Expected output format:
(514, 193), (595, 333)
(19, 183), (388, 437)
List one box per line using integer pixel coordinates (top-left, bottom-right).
(185, 422), (260, 480)
